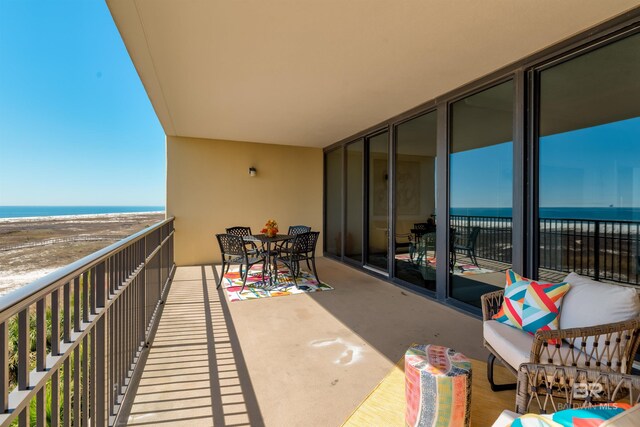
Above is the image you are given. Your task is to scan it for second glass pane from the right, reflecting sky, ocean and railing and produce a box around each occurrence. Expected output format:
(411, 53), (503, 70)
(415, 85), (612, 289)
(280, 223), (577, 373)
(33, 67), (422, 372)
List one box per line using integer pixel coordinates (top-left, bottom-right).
(449, 81), (513, 307)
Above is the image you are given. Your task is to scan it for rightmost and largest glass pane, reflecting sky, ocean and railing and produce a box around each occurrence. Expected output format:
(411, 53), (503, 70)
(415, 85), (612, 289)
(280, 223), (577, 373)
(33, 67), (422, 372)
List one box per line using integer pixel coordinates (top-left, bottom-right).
(538, 35), (640, 285)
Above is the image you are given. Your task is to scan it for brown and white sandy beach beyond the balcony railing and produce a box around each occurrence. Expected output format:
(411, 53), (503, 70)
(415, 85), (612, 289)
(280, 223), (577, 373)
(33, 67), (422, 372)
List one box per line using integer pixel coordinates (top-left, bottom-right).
(0, 212), (164, 296)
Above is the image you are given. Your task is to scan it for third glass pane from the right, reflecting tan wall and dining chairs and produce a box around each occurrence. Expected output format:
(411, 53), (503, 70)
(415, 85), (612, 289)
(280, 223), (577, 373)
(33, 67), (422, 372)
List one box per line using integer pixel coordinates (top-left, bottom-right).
(395, 111), (437, 291)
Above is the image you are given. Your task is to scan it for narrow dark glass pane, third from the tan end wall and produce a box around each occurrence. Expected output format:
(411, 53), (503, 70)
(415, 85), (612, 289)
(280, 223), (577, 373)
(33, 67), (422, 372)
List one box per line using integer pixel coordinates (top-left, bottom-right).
(367, 132), (389, 270)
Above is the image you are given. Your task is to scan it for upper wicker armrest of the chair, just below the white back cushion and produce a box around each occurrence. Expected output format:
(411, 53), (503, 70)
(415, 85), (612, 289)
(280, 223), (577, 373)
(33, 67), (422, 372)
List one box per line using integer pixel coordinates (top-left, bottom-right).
(530, 318), (640, 373)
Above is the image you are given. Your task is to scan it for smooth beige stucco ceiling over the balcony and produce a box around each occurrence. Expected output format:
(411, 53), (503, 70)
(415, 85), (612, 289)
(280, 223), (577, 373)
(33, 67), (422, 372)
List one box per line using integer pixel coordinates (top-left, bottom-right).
(107, 0), (640, 147)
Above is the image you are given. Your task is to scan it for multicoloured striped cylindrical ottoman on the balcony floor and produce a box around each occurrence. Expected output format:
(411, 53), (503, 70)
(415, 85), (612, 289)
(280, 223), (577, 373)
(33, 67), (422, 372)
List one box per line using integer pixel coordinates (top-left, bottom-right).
(404, 345), (471, 427)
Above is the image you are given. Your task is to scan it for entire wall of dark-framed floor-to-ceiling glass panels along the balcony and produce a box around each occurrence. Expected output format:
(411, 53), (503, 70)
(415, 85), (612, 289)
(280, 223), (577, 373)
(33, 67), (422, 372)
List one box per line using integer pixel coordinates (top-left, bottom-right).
(325, 15), (640, 313)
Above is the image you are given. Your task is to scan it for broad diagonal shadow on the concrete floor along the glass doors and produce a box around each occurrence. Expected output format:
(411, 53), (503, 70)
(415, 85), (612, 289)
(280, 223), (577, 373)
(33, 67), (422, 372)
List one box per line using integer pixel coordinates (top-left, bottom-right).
(308, 258), (487, 363)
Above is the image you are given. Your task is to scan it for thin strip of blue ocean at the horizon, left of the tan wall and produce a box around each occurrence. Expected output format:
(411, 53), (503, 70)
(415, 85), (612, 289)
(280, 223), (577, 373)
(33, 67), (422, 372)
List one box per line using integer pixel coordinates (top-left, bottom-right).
(0, 206), (164, 218)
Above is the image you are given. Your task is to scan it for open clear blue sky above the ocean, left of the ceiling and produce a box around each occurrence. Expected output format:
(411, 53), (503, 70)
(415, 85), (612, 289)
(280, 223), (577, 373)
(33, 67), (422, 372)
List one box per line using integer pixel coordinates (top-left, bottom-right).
(0, 0), (166, 205)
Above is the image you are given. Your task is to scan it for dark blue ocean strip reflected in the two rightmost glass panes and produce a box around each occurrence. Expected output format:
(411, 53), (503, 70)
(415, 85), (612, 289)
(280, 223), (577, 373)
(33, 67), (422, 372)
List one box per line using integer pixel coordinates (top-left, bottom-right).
(451, 207), (640, 221)
